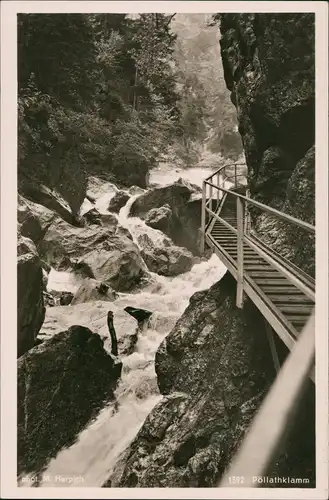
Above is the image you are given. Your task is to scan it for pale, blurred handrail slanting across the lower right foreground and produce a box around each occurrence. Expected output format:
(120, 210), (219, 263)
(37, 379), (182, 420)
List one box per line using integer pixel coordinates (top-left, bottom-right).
(218, 310), (315, 488)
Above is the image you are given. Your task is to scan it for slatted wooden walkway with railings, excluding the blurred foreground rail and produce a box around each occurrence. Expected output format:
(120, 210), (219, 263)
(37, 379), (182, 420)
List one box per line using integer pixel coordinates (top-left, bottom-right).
(201, 164), (315, 381)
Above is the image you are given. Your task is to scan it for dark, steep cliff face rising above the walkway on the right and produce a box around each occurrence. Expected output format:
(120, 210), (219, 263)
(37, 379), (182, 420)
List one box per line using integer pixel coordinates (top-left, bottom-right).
(220, 13), (315, 275)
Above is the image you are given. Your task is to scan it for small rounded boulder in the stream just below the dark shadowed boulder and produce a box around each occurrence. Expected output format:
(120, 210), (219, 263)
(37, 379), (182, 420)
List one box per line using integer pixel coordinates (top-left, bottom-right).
(138, 234), (194, 276)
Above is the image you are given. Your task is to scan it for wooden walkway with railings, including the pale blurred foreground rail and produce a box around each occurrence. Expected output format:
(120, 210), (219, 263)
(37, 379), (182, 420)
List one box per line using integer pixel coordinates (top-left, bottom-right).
(201, 164), (315, 487)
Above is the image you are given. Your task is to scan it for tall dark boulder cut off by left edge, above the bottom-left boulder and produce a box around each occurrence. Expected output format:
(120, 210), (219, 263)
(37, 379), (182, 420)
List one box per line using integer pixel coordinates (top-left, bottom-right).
(17, 237), (45, 356)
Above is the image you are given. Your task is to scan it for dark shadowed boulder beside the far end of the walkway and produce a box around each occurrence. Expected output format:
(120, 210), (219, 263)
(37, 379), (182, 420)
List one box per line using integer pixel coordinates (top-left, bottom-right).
(130, 179), (201, 254)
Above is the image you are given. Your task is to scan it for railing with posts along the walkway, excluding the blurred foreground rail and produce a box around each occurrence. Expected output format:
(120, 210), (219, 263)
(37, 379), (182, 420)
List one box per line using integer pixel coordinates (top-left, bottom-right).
(200, 164), (315, 308)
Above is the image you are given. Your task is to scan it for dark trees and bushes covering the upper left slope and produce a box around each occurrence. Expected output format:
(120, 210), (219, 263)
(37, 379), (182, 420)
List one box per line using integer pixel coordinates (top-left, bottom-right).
(18, 14), (178, 201)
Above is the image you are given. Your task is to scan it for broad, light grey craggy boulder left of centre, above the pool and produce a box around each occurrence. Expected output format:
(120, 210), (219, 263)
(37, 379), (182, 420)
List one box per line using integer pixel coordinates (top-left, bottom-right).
(39, 216), (147, 291)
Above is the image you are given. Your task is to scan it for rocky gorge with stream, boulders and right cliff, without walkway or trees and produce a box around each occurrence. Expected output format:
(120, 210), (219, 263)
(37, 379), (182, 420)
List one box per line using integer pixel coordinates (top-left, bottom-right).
(17, 14), (315, 488)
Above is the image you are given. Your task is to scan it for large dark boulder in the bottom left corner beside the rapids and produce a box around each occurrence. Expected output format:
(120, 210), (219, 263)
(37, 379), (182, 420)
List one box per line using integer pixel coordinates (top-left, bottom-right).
(18, 326), (120, 473)
